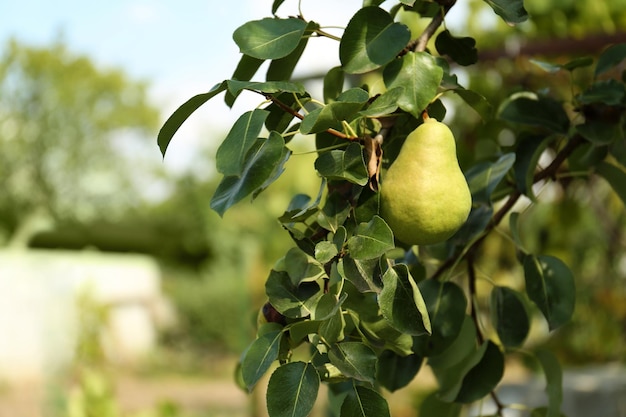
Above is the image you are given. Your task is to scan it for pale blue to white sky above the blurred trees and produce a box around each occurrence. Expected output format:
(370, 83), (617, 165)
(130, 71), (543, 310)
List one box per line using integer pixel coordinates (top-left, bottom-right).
(0, 0), (361, 170)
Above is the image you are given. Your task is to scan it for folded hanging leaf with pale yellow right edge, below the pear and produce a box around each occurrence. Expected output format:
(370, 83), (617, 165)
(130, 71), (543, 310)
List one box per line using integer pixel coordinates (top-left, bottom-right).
(378, 264), (432, 336)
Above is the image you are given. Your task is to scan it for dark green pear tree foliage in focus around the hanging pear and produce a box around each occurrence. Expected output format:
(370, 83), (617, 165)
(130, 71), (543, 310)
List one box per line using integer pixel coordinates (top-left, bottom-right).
(158, 0), (626, 417)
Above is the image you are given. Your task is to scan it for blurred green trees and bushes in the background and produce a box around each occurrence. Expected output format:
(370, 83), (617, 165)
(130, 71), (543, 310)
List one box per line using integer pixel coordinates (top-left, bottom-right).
(0, 0), (626, 414)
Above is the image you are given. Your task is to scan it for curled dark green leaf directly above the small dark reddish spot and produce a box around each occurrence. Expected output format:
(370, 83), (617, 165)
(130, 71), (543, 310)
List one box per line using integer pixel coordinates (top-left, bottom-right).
(265, 270), (321, 319)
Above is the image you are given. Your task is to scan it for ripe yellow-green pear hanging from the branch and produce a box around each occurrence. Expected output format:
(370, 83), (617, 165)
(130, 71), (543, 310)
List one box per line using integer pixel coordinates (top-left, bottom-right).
(380, 118), (472, 245)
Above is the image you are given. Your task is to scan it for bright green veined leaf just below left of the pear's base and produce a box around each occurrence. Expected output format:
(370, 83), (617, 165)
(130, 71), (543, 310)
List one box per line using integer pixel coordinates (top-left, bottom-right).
(348, 216), (394, 259)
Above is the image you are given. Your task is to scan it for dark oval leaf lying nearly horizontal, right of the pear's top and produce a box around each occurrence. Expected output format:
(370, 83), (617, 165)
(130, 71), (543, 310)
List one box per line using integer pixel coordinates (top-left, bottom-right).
(498, 93), (569, 134)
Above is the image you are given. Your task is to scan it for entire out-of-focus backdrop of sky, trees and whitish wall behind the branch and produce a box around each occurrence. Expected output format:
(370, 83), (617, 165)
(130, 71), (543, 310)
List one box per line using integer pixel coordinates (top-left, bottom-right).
(0, 0), (626, 417)
